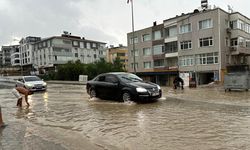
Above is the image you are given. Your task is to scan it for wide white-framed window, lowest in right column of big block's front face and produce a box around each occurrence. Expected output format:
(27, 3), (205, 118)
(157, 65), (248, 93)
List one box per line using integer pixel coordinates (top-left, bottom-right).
(196, 52), (218, 65)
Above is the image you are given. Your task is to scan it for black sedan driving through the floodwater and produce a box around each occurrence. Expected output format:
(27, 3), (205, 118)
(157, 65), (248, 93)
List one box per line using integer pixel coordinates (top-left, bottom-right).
(86, 72), (162, 102)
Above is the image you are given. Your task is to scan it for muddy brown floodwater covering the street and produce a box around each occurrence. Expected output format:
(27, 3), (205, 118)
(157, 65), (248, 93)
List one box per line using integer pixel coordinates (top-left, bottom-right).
(0, 84), (250, 150)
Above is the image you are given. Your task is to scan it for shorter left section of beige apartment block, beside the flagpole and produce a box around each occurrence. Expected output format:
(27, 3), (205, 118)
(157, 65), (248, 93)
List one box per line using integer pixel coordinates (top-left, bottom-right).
(127, 22), (178, 85)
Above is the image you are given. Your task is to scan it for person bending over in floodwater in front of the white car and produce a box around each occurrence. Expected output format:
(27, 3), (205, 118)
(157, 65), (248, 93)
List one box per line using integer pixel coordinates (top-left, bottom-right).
(12, 87), (33, 107)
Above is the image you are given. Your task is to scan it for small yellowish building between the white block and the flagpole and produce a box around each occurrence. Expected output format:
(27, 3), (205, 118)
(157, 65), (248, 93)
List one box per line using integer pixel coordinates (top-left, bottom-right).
(107, 45), (128, 70)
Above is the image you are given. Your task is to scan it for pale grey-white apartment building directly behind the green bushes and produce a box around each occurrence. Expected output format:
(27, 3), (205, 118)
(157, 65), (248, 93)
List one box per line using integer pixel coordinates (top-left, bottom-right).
(32, 34), (106, 70)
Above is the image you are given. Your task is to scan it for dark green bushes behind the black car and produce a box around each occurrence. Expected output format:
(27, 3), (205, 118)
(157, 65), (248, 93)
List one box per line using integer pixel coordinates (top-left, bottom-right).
(53, 58), (125, 81)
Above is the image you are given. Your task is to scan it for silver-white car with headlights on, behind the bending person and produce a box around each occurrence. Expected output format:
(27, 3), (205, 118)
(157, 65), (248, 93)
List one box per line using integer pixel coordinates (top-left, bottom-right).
(16, 76), (47, 91)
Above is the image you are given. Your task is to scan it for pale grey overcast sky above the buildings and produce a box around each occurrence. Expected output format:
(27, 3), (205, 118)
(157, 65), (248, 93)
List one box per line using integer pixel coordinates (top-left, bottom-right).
(0, 0), (250, 46)
